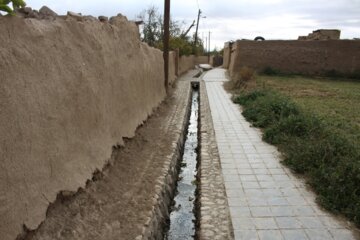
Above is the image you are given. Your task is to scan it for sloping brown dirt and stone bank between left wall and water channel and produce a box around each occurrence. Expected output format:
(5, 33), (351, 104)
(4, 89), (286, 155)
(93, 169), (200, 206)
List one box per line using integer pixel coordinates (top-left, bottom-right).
(18, 78), (190, 240)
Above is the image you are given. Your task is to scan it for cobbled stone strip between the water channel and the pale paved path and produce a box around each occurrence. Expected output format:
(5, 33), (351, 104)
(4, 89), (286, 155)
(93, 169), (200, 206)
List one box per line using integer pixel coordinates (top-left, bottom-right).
(197, 78), (234, 240)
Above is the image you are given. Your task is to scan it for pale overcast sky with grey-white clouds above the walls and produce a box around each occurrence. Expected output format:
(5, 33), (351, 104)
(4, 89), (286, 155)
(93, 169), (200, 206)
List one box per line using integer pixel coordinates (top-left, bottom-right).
(26, 0), (360, 49)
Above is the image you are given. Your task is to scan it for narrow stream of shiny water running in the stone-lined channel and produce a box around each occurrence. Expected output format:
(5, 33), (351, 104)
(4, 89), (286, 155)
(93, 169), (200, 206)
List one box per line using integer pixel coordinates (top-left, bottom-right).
(164, 90), (199, 240)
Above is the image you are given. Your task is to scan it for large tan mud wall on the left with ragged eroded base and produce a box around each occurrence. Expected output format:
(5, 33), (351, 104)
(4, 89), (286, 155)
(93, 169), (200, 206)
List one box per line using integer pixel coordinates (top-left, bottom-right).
(0, 16), (165, 240)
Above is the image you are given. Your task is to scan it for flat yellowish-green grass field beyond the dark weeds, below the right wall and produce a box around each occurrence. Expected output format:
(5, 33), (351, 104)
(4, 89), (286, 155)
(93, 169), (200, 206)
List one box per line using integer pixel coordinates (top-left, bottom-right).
(257, 76), (360, 141)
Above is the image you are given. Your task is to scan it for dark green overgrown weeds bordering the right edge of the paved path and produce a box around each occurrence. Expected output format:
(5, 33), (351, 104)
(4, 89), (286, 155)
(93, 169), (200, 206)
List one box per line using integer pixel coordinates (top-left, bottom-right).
(234, 90), (360, 225)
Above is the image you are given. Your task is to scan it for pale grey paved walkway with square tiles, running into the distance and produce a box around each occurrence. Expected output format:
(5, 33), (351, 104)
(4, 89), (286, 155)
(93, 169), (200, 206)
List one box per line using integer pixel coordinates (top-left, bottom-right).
(203, 69), (355, 240)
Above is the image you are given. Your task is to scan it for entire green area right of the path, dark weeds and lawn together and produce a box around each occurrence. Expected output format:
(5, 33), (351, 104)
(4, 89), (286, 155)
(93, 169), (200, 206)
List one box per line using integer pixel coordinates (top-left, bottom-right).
(234, 77), (360, 226)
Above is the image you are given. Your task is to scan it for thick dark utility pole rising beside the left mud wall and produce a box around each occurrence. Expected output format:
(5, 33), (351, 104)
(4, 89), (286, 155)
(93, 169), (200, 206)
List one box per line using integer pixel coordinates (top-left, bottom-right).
(163, 0), (170, 92)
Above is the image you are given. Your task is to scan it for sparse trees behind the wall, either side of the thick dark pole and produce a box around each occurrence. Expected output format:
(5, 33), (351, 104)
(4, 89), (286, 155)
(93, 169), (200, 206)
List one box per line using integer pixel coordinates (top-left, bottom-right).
(138, 6), (204, 55)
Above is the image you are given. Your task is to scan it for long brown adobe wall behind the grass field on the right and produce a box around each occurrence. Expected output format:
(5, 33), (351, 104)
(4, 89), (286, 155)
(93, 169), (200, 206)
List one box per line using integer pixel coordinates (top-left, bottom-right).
(229, 40), (360, 76)
